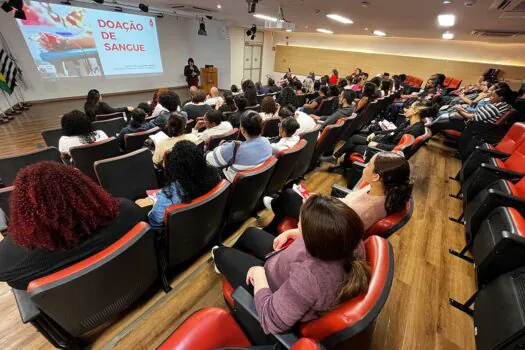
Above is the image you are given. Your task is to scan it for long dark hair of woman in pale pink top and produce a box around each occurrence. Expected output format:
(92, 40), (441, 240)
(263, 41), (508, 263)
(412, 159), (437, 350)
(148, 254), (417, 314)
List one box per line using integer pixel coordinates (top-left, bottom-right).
(374, 152), (413, 215)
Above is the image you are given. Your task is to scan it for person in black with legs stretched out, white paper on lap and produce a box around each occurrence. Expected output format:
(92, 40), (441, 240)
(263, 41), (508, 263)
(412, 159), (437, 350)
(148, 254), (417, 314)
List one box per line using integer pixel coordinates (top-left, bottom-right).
(321, 100), (433, 164)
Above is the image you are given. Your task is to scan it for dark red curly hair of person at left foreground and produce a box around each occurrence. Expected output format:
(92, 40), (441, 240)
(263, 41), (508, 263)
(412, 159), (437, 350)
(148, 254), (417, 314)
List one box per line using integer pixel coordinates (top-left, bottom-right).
(8, 161), (120, 251)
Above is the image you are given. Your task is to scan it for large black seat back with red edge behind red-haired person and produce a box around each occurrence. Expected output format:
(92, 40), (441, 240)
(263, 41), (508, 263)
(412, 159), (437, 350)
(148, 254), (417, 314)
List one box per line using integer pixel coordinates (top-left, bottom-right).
(13, 222), (159, 349)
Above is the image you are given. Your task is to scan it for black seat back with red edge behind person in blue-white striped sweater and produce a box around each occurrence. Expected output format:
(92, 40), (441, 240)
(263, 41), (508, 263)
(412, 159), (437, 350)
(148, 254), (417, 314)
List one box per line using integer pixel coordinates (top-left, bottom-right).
(226, 157), (277, 225)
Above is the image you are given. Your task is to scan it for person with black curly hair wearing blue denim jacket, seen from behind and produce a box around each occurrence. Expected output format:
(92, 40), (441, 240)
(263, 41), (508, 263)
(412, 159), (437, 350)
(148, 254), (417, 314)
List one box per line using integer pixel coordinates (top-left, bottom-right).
(136, 140), (221, 229)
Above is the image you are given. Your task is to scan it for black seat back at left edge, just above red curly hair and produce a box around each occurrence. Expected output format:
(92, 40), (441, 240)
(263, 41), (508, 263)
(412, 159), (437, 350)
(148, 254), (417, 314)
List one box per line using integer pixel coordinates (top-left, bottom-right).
(0, 147), (62, 186)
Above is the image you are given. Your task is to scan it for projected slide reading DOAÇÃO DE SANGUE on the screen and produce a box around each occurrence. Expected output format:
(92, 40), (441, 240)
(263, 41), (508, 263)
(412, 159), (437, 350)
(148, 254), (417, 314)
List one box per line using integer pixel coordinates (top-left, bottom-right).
(17, 1), (162, 78)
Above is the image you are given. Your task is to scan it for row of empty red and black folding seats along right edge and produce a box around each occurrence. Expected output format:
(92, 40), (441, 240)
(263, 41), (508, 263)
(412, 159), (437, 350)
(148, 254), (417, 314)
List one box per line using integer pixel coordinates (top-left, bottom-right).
(449, 123), (525, 349)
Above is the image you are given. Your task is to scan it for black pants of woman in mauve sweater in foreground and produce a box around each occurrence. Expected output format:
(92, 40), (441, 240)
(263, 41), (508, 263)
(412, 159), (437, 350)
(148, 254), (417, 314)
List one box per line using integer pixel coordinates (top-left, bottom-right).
(214, 227), (275, 294)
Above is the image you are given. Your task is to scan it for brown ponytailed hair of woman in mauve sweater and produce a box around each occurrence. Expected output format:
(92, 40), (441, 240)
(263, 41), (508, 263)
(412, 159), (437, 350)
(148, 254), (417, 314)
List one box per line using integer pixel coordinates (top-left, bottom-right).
(300, 195), (370, 307)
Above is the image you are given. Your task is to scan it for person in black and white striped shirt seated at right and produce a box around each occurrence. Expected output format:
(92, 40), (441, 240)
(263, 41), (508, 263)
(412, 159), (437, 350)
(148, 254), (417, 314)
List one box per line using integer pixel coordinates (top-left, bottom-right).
(430, 89), (510, 135)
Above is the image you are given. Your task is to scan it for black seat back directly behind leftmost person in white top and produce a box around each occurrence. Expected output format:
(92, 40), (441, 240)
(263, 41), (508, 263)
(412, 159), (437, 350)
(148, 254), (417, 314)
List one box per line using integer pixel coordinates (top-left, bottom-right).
(69, 137), (118, 183)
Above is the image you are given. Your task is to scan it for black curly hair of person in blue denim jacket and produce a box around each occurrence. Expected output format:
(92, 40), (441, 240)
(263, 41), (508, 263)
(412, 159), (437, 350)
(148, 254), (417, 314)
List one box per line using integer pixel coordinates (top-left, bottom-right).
(162, 140), (220, 203)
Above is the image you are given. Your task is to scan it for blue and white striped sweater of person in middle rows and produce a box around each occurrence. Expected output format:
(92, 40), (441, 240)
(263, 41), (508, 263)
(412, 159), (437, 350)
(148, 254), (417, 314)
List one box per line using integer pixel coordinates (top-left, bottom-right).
(206, 137), (272, 182)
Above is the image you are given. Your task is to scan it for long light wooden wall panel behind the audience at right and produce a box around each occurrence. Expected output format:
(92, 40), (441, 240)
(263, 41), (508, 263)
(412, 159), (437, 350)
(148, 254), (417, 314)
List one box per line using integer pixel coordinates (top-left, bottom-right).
(274, 45), (525, 87)
